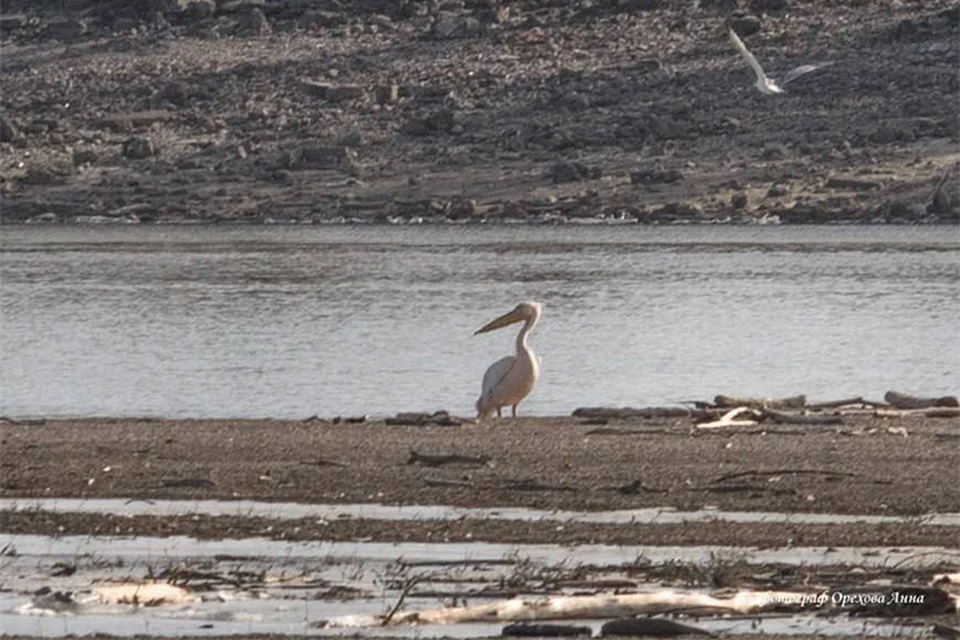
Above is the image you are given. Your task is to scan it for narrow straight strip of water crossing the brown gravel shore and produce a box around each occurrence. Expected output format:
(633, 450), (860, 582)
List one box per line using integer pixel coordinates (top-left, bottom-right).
(0, 498), (960, 527)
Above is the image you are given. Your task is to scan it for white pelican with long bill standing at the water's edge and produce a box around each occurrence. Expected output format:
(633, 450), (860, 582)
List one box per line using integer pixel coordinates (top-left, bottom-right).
(473, 302), (543, 422)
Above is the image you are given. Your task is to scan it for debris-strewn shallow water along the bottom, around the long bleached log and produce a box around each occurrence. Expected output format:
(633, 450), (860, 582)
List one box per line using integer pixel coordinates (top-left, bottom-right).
(0, 535), (960, 638)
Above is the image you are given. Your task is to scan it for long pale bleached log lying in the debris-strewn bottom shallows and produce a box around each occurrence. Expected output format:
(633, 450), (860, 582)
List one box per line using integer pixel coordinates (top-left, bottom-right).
(326, 591), (818, 627)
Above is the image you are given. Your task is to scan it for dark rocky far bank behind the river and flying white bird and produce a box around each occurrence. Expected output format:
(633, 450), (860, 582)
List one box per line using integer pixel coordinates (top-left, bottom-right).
(0, 0), (960, 224)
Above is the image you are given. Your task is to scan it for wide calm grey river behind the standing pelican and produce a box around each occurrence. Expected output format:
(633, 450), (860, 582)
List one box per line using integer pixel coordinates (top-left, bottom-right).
(0, 226), (960, 417)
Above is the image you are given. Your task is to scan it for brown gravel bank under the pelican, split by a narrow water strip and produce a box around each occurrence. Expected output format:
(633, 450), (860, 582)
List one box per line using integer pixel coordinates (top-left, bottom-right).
(0, 417), (960, 546)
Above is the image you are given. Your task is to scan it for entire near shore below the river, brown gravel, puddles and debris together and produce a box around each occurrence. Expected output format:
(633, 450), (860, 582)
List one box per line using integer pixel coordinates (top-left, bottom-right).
(0, 413), (960, 638)
